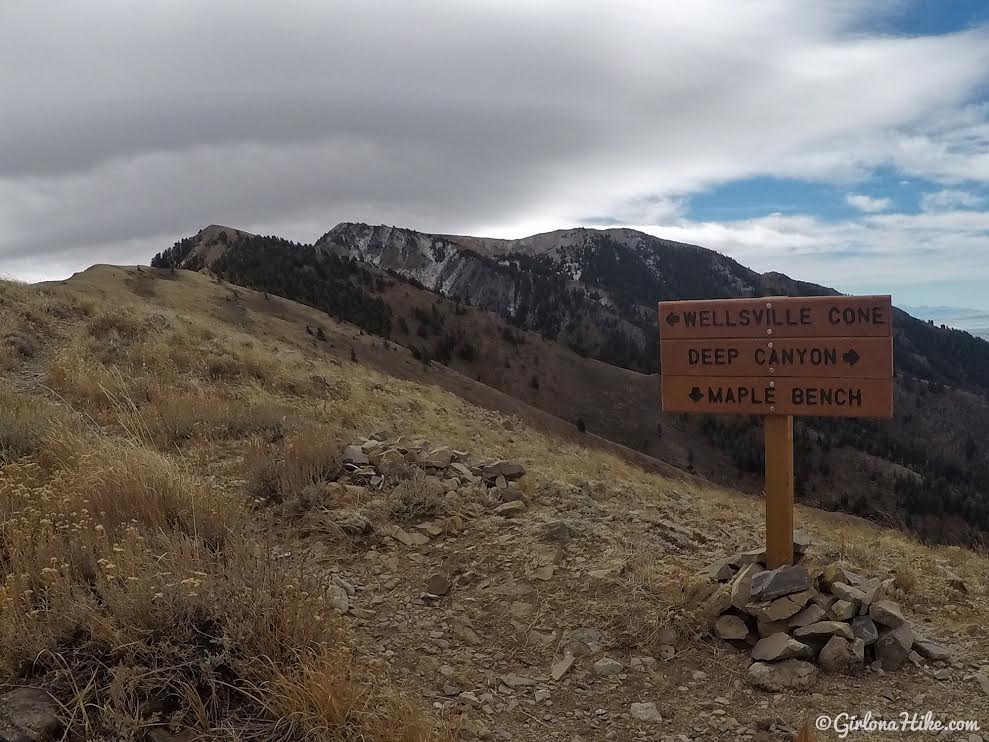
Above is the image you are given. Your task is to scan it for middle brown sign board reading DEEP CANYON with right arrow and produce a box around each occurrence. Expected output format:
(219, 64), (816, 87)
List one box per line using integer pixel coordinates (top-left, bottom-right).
(660, 337), (893, 379)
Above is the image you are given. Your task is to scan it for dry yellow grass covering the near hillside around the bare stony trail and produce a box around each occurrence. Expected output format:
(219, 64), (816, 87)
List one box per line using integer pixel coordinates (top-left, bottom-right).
(0, 267), (989, 742)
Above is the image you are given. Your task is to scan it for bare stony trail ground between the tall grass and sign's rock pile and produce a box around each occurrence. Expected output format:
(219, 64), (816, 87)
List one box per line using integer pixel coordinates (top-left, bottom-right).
(274, 433), (989, 742)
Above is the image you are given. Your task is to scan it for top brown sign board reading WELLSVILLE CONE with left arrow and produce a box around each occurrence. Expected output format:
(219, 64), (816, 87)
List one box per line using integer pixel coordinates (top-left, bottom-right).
(659, 296), (892, 340)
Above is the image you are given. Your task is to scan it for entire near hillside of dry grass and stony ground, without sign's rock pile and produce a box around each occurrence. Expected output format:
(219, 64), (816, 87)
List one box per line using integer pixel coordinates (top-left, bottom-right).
(0, 266), (989, 742)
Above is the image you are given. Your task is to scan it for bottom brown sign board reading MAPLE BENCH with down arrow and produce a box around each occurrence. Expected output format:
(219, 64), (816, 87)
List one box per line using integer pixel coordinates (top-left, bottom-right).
(662, 375), (893, 417)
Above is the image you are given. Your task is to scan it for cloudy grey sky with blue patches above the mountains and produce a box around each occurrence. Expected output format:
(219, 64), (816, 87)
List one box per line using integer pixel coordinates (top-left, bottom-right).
(0, 0), (989, 310)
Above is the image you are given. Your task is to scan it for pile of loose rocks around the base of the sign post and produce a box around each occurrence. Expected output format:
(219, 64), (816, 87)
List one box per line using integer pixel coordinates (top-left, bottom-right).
(704, 531), (951, 693)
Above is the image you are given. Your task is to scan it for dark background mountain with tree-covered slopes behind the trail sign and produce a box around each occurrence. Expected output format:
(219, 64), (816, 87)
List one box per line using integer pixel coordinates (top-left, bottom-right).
(155, 224), (989, 543)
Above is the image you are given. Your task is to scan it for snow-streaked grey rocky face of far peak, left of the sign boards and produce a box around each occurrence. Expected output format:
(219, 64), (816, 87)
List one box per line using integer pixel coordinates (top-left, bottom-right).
(315, 223), (784, 371)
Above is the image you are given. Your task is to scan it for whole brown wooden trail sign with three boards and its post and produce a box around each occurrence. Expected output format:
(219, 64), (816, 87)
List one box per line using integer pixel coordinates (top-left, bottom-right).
(659, 296), (893, 569)
